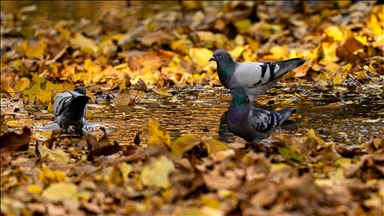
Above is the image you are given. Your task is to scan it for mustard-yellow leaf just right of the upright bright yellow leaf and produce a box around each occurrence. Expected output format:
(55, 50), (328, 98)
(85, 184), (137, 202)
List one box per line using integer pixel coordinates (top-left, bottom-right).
(172, 135), (201, 158)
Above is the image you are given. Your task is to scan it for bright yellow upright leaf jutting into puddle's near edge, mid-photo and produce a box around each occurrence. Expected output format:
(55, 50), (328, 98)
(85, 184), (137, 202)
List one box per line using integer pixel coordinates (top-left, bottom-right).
(146, 118), (171, 147)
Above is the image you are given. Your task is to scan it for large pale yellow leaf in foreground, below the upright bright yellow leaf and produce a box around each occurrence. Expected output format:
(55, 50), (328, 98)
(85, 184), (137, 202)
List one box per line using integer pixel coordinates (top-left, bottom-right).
(140, 155), (175, 188)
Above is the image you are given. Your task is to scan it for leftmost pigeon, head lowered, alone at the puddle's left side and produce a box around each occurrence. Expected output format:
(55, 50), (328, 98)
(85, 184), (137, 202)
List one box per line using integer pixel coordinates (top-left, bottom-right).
(53, 86), (90, 134)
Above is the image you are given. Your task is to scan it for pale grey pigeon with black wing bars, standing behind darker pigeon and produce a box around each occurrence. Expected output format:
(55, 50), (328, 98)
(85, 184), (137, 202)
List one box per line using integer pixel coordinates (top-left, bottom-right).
(209, 49), (305, 101)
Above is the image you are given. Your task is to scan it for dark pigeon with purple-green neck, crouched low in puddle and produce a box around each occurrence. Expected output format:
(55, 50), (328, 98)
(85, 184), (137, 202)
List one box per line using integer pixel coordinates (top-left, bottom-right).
(227, 83), (296, 144)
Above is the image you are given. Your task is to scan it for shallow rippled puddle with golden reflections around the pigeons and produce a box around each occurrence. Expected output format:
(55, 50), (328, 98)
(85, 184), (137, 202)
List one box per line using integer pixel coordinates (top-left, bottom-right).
(2, 83), (378, 145)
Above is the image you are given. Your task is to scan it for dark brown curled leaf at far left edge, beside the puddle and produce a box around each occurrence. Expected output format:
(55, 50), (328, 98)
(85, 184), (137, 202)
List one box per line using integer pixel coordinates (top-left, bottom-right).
(0, 127), (32, 151)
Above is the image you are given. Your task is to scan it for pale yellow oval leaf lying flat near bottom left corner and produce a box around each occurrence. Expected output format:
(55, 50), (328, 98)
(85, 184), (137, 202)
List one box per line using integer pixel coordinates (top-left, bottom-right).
(41, 182), (78, 201)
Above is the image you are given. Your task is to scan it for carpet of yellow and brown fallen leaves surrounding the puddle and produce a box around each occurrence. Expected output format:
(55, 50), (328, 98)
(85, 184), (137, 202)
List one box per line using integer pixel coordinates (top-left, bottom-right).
(0, 1), (384, 215)
